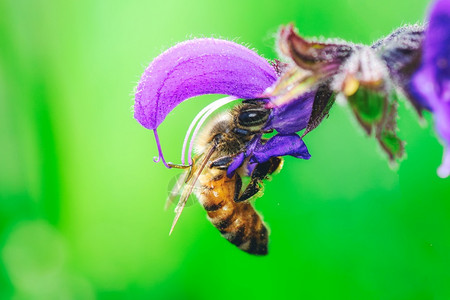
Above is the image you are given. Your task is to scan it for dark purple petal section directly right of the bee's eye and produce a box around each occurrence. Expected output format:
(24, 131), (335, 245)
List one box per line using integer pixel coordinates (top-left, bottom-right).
(266, 92), (315, 134)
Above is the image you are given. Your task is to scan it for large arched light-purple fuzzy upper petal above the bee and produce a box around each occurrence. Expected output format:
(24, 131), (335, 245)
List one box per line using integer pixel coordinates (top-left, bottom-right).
(134, 38), (277, 129)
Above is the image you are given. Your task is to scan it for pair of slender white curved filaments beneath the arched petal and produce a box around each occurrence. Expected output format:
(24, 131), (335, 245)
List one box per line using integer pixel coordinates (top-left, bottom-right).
(181, 96), (238, 165)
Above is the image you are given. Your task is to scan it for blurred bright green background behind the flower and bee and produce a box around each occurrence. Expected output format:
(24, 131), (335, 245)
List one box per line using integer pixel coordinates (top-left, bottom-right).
(0, 0), (450, 299)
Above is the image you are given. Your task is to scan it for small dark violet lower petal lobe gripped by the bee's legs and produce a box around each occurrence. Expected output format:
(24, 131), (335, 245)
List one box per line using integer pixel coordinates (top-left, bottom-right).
(251, 134), (311, 163)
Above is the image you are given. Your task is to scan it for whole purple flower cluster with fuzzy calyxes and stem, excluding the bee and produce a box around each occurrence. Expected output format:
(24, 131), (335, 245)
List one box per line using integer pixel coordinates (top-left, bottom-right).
(135, 0), (450, 177)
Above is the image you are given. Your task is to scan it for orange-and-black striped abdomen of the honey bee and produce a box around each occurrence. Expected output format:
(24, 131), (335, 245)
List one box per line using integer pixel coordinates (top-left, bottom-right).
(195, 169), (268, 255)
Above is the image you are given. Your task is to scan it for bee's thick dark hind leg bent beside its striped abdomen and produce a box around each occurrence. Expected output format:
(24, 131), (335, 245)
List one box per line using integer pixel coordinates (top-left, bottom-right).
(234, 157), (282, 202)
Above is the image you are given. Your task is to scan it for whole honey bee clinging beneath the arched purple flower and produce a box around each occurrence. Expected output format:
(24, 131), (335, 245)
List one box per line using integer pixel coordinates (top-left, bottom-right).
(168, 100), (283, 255)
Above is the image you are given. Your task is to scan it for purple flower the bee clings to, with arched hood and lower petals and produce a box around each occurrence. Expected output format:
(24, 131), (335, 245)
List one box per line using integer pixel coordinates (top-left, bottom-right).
(134, 38), (314, 168)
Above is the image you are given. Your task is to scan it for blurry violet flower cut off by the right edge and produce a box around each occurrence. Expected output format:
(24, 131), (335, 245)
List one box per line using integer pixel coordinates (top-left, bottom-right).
(412, 0), (450, 178)
